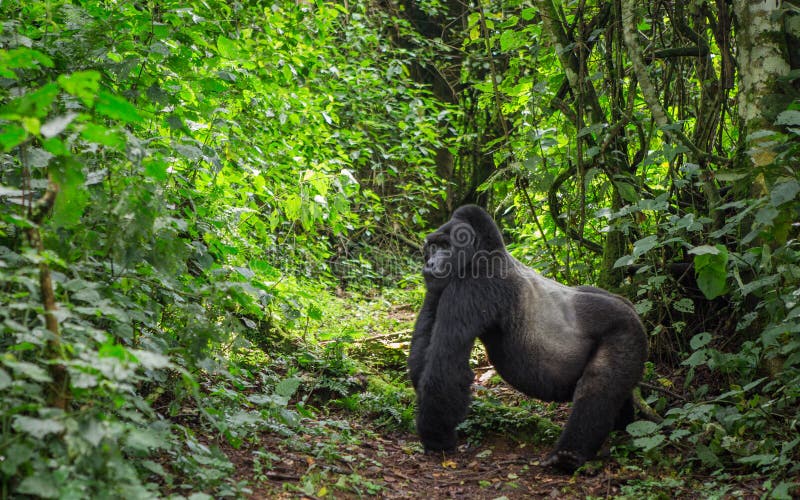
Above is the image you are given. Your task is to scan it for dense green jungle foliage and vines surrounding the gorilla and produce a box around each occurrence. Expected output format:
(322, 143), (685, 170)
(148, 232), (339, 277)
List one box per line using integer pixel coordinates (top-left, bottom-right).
(0, 0), (800, 498)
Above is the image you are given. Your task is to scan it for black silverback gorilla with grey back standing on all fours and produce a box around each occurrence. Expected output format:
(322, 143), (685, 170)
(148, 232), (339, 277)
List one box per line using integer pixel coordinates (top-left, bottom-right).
(408, 205), (647, 471)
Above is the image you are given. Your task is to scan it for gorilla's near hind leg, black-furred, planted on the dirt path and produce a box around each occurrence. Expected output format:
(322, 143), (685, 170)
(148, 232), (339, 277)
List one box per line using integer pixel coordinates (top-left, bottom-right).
(543, 337), (641, 472)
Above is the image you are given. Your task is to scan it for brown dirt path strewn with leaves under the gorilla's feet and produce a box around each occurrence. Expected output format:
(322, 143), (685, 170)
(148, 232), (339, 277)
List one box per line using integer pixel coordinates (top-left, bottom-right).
(221, 423), (638, 499)
